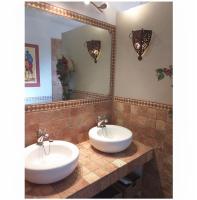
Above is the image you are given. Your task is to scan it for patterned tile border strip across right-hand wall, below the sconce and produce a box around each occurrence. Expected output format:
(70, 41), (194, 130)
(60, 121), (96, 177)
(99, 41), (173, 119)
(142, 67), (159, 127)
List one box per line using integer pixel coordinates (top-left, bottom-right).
(113, 96), (172, 110)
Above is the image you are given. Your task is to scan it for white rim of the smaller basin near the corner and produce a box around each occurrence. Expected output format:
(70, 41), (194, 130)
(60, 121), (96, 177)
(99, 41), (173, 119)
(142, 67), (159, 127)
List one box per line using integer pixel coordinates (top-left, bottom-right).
(88, 124), (133, 143)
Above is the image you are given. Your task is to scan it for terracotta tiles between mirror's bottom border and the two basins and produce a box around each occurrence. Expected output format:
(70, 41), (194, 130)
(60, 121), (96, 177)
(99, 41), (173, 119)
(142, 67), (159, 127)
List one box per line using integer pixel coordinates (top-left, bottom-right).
(25, 101), (112, 146)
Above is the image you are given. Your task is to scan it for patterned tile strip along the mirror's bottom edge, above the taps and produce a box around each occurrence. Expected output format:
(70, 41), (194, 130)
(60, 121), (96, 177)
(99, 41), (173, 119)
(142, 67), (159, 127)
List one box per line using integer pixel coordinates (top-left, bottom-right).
(25, 97), (112, 112)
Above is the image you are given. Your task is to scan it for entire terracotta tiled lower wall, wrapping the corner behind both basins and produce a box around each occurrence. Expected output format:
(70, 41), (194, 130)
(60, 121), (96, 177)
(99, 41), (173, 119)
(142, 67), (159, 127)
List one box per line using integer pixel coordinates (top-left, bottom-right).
(25, 97), (172, 198)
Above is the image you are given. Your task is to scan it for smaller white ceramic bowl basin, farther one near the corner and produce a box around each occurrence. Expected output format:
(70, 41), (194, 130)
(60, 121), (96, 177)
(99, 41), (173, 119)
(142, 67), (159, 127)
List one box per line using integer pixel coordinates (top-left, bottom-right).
(89, 125), (132, 153)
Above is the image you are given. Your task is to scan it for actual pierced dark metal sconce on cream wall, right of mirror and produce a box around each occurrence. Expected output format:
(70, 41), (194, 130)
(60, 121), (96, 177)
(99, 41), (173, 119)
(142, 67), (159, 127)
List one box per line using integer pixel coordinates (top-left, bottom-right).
(129, 29), (152, 60)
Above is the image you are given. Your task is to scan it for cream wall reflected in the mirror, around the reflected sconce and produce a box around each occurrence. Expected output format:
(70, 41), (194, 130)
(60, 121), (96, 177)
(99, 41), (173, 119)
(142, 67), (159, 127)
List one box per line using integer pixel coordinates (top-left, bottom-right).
(62, 25), (111, 95)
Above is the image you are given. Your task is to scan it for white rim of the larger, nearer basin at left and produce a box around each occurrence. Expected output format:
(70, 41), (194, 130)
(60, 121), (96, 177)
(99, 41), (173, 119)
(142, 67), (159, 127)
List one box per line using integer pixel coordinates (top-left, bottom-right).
(25, 140), (79, 171)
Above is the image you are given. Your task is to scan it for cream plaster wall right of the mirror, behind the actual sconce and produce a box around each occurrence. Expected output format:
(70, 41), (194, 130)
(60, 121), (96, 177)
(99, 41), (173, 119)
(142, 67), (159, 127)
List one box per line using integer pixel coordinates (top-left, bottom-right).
(115, 2), (173, 104)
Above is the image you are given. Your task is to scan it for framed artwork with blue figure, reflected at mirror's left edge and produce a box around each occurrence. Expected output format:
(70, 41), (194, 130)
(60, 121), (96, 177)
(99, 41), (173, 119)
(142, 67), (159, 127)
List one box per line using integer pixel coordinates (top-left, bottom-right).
(25, 43), (40, 87)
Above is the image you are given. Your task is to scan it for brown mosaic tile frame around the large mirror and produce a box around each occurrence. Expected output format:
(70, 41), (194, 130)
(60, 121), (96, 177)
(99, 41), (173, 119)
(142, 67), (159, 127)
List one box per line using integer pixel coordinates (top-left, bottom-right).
(25, 2), (116, 112)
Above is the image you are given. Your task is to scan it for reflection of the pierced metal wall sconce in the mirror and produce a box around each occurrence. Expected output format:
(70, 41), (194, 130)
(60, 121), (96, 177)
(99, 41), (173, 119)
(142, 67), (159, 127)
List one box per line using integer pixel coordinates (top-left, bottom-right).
(86, 40), (101, 63)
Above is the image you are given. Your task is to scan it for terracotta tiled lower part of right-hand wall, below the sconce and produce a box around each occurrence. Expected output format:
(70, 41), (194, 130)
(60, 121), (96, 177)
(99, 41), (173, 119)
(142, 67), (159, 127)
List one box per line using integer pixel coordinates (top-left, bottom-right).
(112, 98), (172, 198)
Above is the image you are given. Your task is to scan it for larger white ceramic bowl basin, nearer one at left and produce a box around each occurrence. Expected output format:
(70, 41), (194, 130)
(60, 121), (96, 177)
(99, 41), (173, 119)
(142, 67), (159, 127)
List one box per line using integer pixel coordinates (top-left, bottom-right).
(25, 140), (79, 184)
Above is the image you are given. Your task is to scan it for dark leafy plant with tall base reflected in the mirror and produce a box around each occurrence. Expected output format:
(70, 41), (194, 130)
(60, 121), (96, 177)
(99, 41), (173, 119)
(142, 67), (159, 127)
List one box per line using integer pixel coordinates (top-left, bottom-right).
(56, 56), (74, 100)
